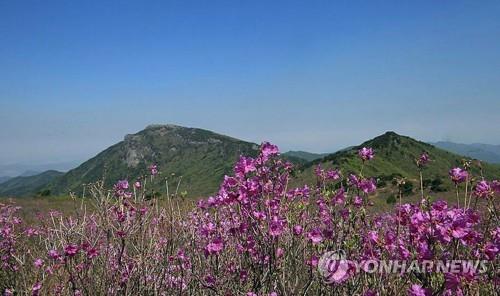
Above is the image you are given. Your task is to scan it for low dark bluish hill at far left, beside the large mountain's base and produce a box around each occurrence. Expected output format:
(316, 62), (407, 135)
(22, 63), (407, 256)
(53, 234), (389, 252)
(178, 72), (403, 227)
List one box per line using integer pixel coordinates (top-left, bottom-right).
(0, 170), (64, 196)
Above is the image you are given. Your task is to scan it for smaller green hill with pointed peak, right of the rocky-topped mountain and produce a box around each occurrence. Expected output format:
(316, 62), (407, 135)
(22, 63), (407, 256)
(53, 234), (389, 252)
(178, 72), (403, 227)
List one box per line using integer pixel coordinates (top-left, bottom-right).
(299, 132), (500, 189)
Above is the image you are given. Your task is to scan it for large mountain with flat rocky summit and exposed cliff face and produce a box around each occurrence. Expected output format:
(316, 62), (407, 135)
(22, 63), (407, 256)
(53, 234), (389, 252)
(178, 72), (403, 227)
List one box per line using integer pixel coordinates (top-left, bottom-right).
(47, 125), (258, 196)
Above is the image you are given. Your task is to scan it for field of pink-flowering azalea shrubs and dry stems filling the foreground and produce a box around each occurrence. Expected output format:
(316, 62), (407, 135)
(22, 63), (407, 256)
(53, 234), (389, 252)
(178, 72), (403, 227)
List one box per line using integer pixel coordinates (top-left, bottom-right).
(0, 143), (500, 296)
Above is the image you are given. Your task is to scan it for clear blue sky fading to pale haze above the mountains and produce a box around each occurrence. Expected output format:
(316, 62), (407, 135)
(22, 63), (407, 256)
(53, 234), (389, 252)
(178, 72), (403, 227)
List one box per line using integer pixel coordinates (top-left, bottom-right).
(0, 0), (500, 164)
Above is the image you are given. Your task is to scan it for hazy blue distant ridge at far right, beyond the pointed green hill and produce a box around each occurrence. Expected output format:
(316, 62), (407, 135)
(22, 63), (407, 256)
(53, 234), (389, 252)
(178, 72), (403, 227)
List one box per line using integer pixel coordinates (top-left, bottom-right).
(430, 141), (500, 163)
